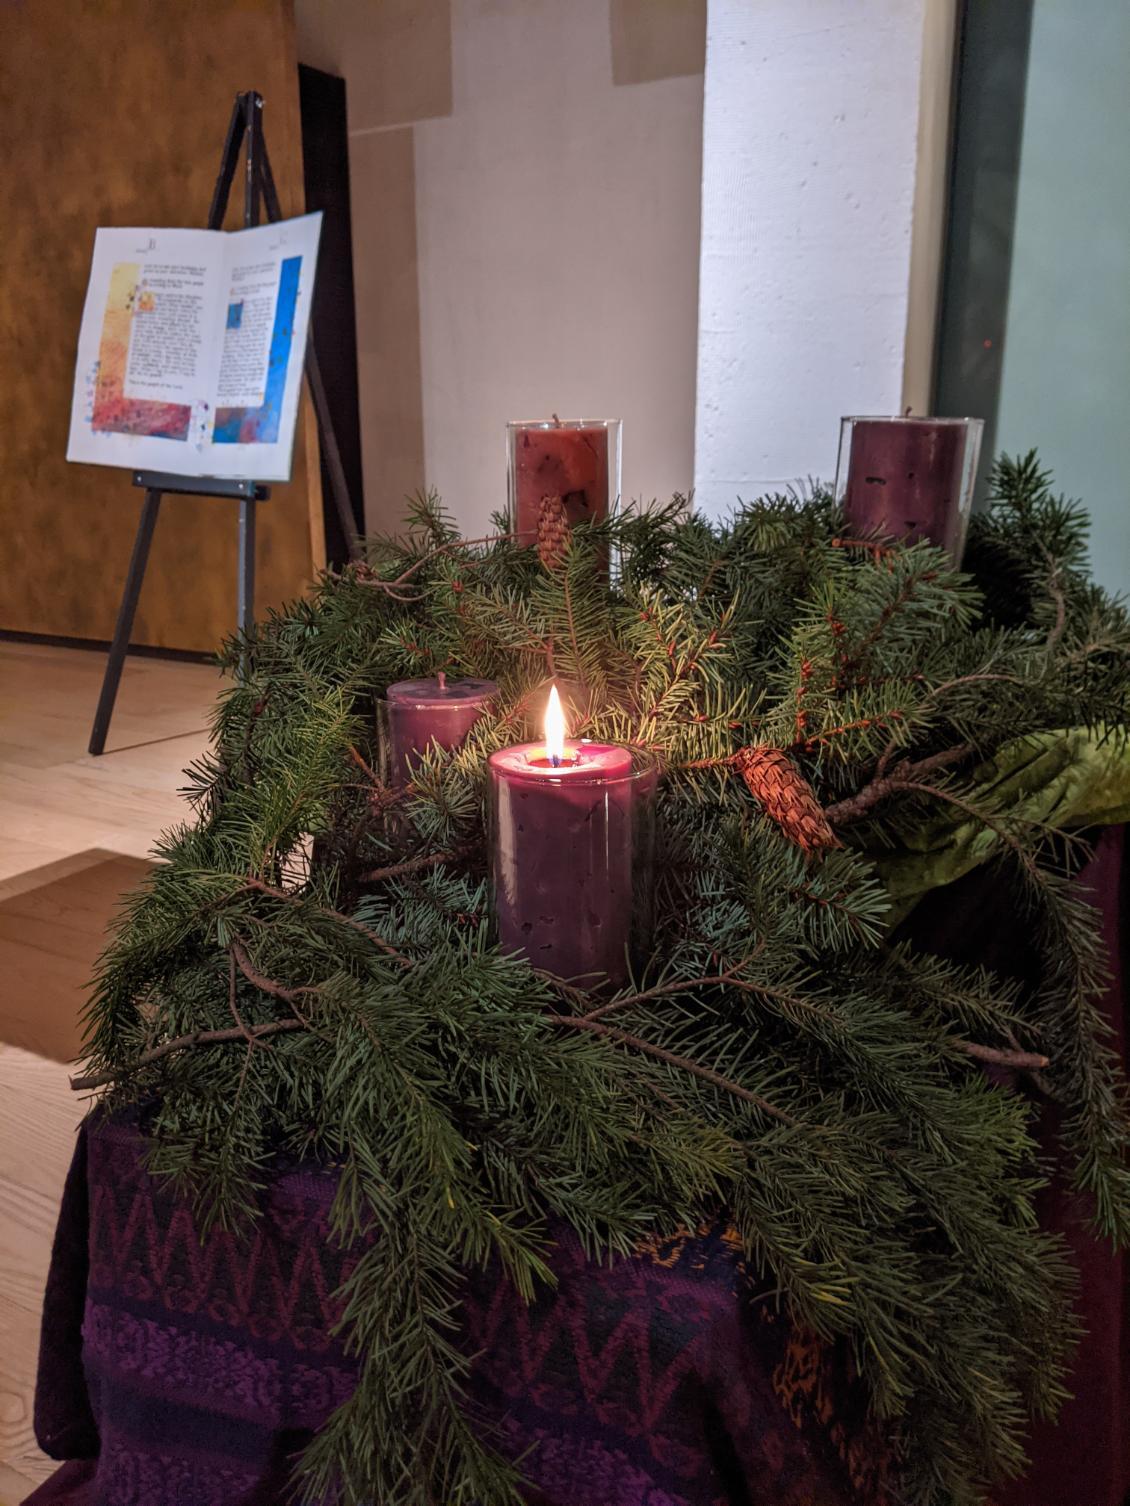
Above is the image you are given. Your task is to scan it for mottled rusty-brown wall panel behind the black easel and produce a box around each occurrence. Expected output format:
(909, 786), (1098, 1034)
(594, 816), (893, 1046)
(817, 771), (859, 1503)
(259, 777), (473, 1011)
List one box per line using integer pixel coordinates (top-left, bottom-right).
(0, 0), (321, 649)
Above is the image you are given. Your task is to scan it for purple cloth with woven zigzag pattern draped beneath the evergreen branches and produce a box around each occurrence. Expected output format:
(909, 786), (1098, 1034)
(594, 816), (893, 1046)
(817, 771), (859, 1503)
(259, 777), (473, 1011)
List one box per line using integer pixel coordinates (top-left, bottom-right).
(26, 1117), (869, 1506)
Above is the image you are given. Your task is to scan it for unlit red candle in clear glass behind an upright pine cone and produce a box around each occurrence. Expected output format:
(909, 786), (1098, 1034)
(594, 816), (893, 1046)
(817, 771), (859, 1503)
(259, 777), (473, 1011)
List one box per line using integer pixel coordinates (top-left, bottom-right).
(506, 419), (622, 545)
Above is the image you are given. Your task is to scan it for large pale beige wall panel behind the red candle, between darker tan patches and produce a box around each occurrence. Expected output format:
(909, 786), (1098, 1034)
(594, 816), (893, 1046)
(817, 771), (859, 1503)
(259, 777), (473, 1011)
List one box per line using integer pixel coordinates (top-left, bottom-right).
(414, 0), (702, 530)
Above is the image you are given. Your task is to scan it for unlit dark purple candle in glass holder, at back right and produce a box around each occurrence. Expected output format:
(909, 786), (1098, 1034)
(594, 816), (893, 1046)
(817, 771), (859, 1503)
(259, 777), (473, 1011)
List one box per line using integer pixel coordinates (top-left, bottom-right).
(836, 417), (984, 565)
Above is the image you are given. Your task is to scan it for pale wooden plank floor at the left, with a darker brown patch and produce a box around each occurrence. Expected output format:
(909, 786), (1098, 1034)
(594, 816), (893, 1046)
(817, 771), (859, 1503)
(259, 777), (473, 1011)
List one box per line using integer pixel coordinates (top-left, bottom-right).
(0, 642), (221, 1506)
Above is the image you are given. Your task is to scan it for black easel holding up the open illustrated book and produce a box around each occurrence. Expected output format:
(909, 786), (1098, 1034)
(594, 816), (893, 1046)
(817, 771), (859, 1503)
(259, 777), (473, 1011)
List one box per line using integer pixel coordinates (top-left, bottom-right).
(90, 89), (360, 756)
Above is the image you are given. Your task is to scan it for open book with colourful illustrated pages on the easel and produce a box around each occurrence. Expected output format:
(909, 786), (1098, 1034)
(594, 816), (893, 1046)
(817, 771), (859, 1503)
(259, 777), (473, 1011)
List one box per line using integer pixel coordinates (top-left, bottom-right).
(66, 212), (322, 480)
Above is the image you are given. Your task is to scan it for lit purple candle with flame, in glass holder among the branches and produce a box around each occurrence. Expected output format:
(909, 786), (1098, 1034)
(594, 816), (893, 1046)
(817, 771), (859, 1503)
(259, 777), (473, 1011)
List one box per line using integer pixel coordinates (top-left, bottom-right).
(487, 685), (655, 985)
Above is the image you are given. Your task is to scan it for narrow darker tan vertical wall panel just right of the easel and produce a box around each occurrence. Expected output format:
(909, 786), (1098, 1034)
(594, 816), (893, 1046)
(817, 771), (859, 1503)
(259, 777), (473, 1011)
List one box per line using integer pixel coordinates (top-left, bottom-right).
(350, 127), (425, 529)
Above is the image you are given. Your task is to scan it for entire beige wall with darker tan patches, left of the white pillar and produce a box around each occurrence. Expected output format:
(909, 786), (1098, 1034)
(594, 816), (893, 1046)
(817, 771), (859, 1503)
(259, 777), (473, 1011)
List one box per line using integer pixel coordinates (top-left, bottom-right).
(295, 0), (705, 533)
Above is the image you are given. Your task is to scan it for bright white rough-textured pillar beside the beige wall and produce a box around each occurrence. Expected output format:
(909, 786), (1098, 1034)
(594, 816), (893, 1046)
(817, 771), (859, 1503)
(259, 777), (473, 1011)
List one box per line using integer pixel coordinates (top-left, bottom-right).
(695, 0), (928, 515)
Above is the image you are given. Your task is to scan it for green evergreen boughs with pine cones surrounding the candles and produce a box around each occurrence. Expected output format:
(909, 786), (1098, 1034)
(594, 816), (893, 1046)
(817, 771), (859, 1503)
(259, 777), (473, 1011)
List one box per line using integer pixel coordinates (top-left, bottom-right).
(75, 456), (1130, 1506)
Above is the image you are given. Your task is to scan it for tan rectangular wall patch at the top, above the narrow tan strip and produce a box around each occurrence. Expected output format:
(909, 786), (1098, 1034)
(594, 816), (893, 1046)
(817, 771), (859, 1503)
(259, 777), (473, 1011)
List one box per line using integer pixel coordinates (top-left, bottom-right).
(295, 0), (452, 131)
